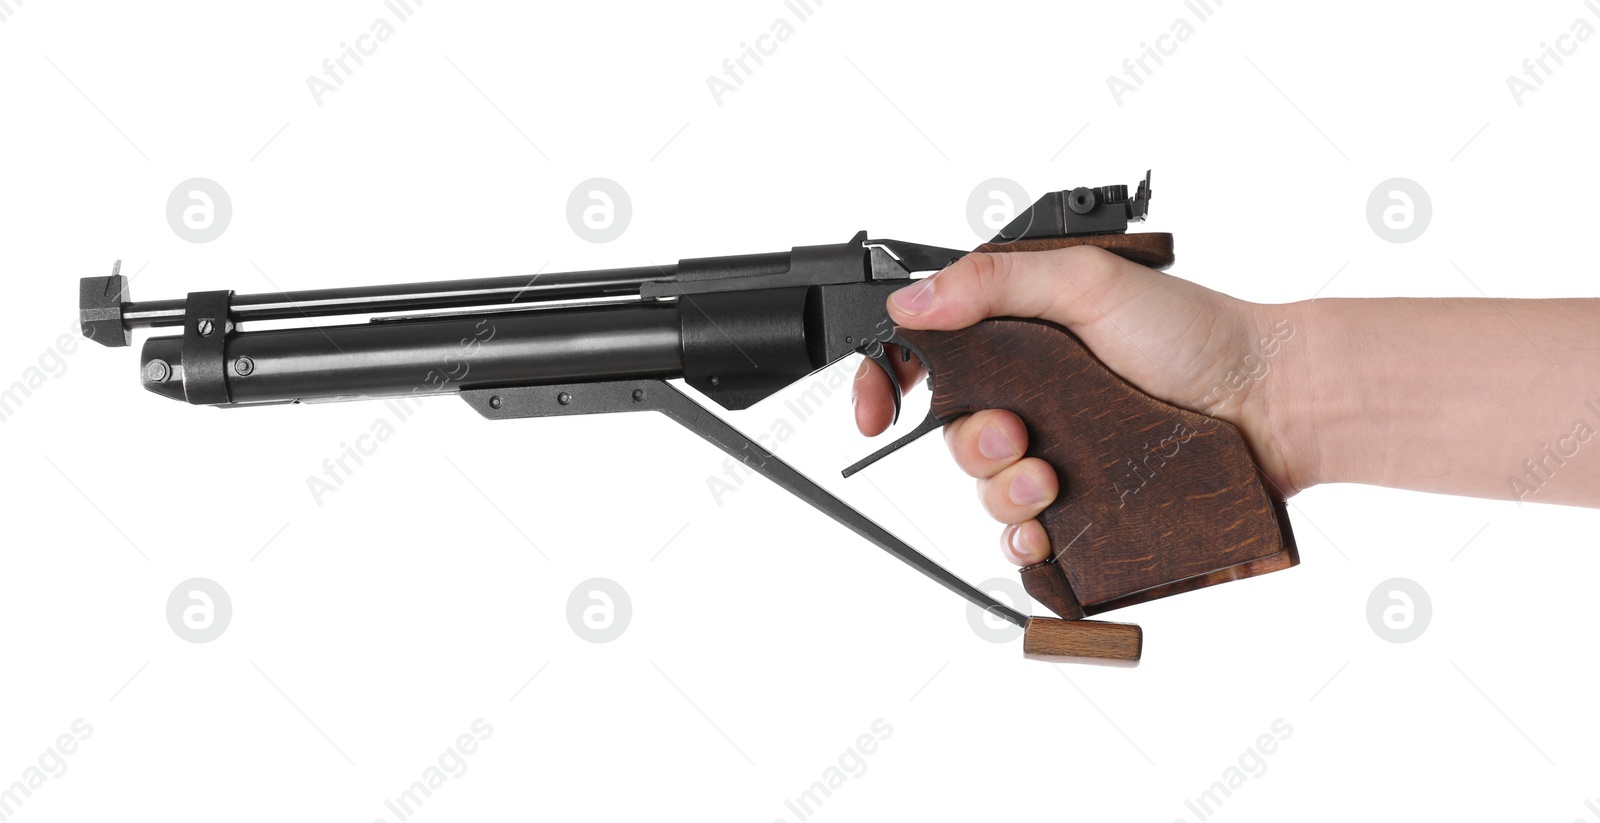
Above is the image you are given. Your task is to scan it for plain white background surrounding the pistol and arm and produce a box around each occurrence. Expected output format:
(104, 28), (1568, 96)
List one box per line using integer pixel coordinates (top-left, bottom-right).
(0, 0), (1600, 821)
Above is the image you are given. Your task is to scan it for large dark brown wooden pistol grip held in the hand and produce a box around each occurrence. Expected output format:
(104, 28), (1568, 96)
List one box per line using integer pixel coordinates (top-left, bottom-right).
(894, 317), (1299, 620)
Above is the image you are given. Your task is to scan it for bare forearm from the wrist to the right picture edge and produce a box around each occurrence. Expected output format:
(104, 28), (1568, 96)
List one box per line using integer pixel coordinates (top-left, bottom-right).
(1280, 298), (1600, 506)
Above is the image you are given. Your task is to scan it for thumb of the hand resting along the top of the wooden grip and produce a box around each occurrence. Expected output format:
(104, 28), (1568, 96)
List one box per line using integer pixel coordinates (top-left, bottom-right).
(888, 247), (1139, 331)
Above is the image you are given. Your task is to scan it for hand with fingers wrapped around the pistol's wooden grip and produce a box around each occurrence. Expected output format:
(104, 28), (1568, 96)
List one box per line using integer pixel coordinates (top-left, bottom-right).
(853, 247), (1296, 565)
